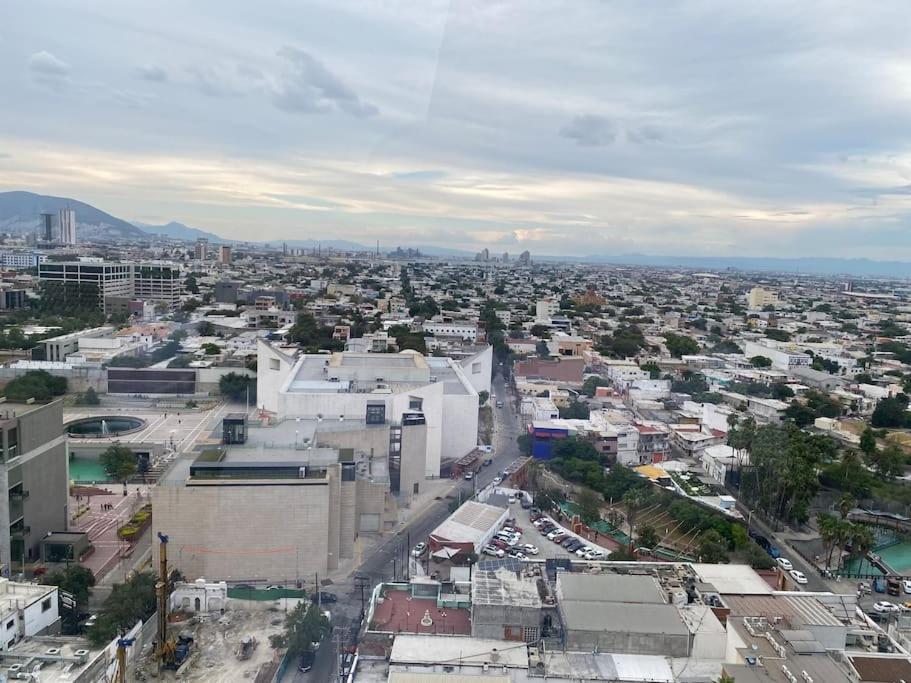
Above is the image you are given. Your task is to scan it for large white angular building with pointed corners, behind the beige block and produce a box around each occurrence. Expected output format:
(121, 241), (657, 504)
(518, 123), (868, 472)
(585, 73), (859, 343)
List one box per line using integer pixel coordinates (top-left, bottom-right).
(257, 341), (493, 477)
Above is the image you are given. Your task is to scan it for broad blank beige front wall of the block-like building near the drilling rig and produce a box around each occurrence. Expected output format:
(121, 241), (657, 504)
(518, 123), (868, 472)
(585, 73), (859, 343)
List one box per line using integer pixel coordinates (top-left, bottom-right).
(151, 481), (338, 582)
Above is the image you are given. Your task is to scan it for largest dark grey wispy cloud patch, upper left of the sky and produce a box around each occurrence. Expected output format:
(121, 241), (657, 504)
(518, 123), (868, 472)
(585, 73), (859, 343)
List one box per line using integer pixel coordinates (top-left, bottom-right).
(273, 46), (379, 118)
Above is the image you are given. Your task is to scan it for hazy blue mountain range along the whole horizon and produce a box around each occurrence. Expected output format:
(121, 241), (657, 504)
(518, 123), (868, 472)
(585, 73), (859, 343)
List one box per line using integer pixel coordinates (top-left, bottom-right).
(0, 191), (911, 278)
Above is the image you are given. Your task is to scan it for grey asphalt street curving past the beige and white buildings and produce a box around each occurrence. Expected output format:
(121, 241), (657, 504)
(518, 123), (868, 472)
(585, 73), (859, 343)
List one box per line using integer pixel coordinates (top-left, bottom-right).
(283, 373), (521, 683)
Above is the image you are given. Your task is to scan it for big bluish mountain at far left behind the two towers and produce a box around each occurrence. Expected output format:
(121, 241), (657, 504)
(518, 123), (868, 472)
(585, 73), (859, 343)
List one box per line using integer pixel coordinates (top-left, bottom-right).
(0, 191), (146, 240)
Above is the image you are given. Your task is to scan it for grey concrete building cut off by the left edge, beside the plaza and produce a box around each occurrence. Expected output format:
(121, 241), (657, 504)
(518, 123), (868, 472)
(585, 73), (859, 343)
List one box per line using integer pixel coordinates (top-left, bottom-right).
(0, 401), (69, 576)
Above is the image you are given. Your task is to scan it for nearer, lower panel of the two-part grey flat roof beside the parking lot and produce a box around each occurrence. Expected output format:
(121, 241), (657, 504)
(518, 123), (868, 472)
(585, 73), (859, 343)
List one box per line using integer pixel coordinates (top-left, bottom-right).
(559, 600), (690, 636)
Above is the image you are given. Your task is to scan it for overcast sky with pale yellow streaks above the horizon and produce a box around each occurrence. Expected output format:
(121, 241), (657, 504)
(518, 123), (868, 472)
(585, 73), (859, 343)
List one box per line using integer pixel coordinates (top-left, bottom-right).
(0, 0), (911, 258)
